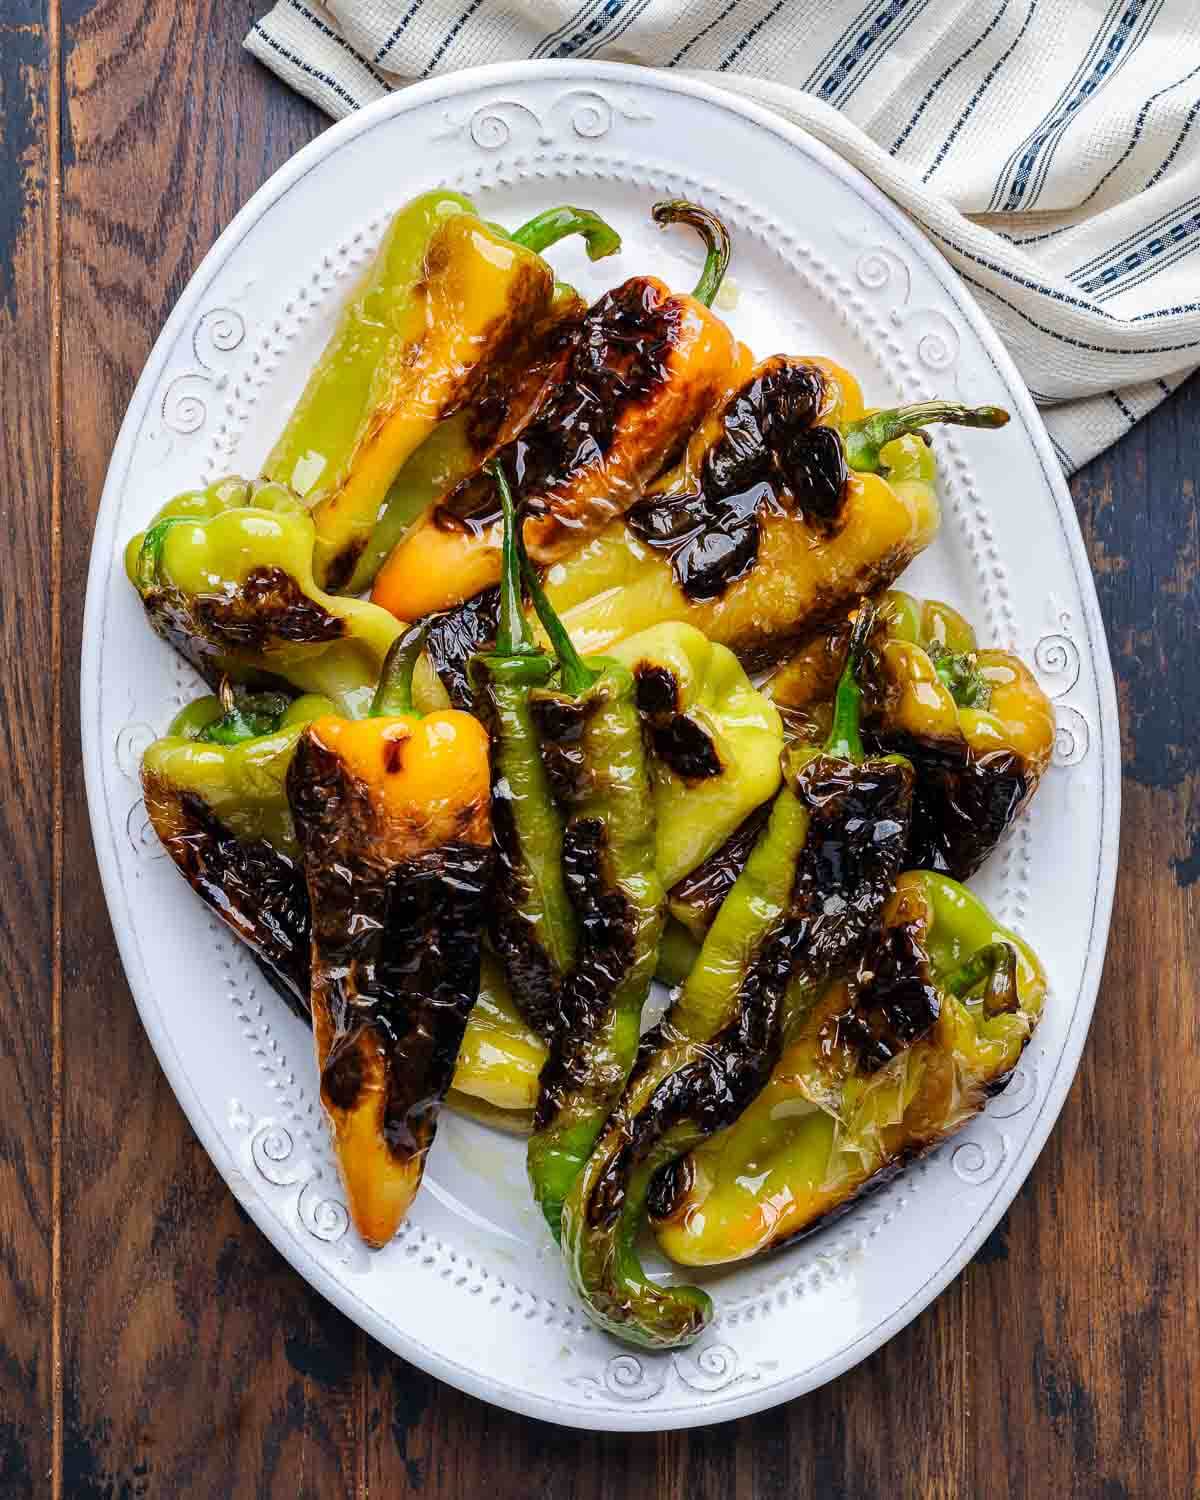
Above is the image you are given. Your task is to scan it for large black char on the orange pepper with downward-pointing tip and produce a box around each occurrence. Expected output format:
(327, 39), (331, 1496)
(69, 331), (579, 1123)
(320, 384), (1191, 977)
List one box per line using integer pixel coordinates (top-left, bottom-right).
(288, 734), (492, 1158)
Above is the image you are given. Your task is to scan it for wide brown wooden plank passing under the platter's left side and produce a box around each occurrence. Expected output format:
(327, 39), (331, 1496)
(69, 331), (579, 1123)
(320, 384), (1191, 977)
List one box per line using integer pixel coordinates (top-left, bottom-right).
(60, 0), (363, 1500)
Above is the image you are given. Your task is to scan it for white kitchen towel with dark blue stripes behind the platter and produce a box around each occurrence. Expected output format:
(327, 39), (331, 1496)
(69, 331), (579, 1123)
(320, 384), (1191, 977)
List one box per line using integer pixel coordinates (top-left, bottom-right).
(246, 0), (1200, 473)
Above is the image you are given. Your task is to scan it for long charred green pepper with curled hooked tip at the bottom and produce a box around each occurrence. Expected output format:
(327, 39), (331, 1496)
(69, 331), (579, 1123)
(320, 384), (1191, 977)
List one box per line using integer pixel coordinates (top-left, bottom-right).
(563, 611), (912, 1349)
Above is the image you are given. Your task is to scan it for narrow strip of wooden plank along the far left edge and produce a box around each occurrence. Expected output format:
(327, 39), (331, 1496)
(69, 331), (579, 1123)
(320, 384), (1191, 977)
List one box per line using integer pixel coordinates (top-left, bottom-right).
(0, 0), (56, 1500)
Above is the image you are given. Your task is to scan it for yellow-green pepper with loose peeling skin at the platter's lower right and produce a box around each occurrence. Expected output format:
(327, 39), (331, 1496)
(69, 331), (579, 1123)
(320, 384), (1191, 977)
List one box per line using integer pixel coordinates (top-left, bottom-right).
(651, 870), (1046, 1266)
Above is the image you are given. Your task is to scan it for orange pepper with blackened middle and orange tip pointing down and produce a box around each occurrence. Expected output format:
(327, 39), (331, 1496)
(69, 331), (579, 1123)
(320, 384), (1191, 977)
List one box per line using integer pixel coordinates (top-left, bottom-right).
(288, 638), (492, 1248)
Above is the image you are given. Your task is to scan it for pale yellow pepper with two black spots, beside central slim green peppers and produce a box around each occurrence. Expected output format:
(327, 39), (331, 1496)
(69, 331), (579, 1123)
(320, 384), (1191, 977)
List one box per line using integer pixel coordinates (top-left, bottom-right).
(611, 624), (783, 887)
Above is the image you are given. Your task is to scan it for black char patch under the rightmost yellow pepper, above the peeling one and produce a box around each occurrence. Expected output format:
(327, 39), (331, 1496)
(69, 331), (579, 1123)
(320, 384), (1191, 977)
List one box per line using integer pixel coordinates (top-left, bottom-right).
(872, 731), (1037, 881)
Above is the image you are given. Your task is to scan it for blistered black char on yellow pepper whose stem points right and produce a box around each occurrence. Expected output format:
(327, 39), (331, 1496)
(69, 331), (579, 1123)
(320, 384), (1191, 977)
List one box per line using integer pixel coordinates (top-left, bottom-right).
(626, 356), (848, 600)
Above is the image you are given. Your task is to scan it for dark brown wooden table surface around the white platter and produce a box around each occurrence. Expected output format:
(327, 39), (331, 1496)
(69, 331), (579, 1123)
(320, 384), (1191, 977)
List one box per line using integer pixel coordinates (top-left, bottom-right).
(0, 0), (1200, 1500)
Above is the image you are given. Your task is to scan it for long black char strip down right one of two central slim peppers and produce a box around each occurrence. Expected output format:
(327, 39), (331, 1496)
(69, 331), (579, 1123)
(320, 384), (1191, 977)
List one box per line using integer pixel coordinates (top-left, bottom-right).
(534, 818), (638, 1130)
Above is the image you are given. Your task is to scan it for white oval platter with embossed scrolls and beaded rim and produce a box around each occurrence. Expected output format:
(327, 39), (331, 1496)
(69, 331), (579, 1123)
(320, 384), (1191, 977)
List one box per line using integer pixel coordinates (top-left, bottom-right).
(83, 63), (1119, 1430)
